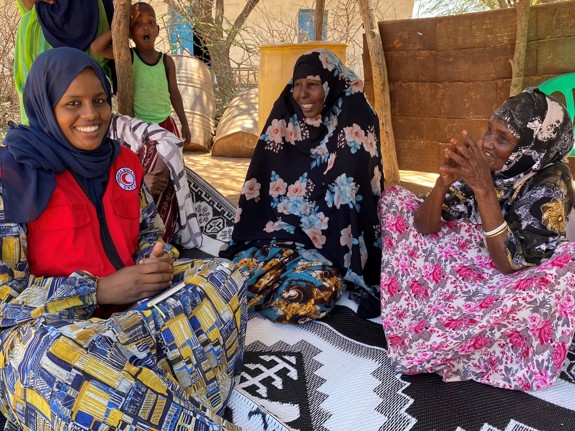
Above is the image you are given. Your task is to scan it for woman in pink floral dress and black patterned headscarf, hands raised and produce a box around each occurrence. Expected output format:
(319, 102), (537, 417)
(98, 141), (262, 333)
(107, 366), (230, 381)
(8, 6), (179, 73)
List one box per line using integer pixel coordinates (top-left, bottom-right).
(379, 88), (575, 390)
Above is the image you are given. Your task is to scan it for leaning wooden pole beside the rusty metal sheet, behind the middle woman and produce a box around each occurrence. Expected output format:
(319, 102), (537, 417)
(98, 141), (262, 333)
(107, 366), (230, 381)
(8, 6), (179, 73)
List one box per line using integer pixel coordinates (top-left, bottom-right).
(358, 0), (399, 185)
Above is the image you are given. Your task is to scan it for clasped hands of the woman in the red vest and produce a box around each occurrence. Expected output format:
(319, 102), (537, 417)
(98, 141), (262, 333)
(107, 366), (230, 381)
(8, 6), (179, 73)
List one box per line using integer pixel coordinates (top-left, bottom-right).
(96, 248), (173, 305)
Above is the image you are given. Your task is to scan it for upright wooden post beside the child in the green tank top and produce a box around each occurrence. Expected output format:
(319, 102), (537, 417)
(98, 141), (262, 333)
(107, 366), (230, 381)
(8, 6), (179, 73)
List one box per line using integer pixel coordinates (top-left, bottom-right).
(112, 0), (134, 117)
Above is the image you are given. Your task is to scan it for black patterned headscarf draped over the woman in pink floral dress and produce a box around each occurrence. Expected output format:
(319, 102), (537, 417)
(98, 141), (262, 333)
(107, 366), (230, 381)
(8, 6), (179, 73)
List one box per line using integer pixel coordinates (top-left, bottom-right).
(443, 88), (575, 269)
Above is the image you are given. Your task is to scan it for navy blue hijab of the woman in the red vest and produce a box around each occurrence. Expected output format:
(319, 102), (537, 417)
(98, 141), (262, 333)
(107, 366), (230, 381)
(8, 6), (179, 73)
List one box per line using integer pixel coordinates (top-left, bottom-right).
(0, 48), (120, 223)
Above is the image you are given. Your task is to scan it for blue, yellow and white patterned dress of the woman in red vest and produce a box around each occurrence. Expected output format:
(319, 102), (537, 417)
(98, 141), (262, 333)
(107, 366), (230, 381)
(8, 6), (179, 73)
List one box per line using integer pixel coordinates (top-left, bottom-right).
(0, 181), (247, 431)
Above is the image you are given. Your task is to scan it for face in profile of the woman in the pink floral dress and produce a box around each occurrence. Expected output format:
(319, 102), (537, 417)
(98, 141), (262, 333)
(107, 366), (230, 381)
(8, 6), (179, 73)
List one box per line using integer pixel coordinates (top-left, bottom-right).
(481, 117), (519, 172)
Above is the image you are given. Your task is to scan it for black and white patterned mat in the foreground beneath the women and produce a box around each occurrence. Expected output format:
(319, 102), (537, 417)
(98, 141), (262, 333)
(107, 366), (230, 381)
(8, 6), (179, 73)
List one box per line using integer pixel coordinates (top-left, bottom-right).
(226, 298), (575, 431)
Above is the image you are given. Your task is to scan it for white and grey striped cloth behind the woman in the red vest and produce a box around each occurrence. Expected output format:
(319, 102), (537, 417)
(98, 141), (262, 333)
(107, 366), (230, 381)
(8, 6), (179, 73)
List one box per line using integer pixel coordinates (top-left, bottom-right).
(109, 115), (202, 248)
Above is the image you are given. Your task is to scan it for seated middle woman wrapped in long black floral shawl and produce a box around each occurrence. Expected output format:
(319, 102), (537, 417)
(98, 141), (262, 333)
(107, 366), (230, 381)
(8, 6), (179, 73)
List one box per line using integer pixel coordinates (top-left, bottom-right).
(220, 49), (383, 323)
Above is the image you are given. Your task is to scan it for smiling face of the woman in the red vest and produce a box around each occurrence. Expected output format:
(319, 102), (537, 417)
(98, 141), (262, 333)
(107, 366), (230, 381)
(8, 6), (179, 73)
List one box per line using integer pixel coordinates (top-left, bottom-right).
(54, 68), (112, 150)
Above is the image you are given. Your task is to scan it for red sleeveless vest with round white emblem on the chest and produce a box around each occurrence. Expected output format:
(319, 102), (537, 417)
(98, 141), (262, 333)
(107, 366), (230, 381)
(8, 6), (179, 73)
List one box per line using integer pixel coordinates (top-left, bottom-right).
(28, 147), (144, 277)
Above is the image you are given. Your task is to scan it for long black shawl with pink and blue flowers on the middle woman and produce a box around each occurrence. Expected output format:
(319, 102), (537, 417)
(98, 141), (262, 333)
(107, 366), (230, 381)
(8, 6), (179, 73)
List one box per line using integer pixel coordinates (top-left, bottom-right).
(220, 50), (383, 320)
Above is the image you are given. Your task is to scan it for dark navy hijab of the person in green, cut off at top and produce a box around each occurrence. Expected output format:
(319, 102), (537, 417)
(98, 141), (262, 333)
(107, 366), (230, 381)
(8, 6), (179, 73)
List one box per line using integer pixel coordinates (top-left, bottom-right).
(36, 0), (114, 51)
